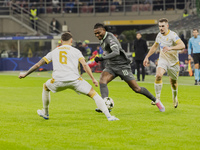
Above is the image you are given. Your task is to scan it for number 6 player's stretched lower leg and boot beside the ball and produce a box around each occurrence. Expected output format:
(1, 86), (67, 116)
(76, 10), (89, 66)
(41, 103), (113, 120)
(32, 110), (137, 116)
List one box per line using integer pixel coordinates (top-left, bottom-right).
(88, 88), (119, 121)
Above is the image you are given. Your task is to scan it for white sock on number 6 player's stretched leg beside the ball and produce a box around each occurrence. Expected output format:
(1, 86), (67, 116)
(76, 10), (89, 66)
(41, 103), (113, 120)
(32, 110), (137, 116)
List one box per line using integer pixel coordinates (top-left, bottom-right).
(93, 93), (111, 118)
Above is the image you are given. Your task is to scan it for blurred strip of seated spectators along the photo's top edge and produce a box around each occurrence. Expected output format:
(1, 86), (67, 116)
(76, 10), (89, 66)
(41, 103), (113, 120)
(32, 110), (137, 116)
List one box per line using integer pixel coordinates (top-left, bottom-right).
(0, 0), (189, 13)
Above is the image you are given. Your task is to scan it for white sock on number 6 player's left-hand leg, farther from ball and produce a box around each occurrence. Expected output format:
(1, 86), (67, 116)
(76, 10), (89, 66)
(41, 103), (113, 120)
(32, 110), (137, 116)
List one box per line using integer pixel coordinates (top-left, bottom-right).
(42, 88), (50, 115)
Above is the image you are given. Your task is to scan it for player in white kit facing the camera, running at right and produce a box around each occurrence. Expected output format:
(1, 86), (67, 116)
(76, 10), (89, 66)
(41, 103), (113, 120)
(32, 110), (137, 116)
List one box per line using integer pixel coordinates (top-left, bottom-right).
(143, 18), (185, 108)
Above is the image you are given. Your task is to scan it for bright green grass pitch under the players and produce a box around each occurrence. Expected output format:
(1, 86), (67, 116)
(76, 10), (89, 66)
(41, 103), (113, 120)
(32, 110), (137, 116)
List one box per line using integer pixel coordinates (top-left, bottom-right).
(0, 72), (200, 150)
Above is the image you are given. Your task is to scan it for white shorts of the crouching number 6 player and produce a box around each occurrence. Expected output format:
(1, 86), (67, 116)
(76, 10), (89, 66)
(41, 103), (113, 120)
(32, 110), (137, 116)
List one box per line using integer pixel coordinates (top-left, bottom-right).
(46, 78), (92, 95)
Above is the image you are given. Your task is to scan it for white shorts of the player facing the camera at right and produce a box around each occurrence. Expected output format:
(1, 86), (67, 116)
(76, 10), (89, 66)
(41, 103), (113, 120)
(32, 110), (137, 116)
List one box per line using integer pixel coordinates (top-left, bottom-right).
(157, 60), (180, 80)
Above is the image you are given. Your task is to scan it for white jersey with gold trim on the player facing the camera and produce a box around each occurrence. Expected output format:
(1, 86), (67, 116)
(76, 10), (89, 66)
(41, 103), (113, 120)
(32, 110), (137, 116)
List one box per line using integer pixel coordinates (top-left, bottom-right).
(156, 30), (180, 66)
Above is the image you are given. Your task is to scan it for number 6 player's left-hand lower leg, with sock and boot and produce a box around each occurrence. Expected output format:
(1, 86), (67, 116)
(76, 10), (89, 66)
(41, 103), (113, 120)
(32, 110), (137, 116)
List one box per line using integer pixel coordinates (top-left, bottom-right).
(37, 83), (50, 119)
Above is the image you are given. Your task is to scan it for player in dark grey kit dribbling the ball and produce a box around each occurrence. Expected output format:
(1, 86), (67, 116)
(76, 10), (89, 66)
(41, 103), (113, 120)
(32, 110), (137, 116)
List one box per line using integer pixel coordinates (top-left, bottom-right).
(94, 23), (165, 112)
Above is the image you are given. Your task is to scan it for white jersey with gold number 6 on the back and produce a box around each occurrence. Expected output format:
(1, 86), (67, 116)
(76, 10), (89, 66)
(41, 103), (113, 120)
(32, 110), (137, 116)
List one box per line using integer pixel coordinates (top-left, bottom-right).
(43, 45), (84, 81)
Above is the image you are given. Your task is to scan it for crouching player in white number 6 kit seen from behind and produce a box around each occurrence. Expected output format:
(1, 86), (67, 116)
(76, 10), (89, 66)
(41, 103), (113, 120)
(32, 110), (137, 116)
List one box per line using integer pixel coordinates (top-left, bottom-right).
(19, 32), (119, 121)
